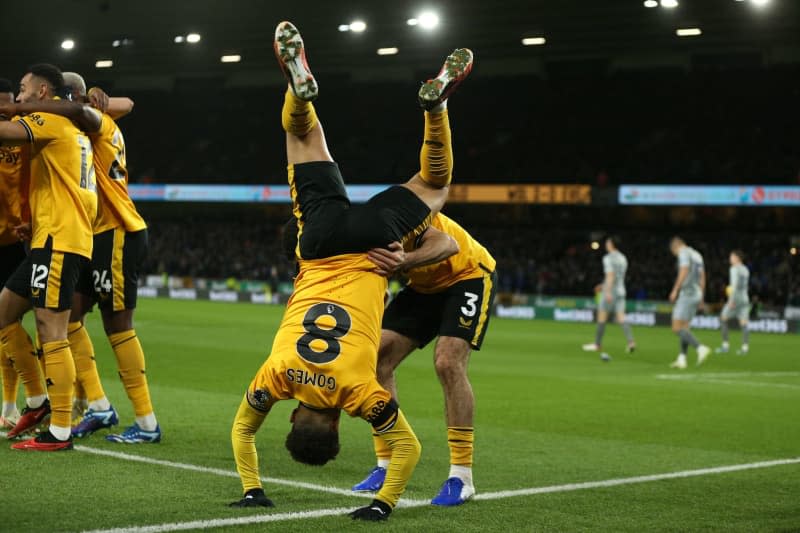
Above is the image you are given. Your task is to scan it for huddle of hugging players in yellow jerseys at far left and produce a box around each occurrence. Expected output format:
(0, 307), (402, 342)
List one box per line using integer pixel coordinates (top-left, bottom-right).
(0, 64), (161, 451)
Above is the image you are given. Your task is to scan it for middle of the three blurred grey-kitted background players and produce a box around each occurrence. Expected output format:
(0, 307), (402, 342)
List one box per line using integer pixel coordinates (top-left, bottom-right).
(669, 237), (711, 370)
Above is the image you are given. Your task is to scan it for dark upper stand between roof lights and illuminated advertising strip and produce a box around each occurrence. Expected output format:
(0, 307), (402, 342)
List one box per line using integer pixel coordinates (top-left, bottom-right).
(120, 67), (800, 186)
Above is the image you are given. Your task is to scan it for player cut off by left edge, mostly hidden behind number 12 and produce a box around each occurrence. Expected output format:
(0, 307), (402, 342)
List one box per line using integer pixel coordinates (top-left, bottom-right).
(0, 78), (32, 429)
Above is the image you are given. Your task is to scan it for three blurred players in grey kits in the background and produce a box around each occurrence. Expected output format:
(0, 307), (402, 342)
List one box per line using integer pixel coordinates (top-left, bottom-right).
(583, 236), (750, 370)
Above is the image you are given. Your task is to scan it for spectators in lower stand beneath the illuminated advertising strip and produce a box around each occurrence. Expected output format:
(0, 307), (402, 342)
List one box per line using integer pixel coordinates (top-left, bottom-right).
(145, 218), (800, 306)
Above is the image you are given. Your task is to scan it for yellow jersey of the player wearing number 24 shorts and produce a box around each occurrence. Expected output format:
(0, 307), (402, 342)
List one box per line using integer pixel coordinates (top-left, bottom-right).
(89, 113), (147, 233)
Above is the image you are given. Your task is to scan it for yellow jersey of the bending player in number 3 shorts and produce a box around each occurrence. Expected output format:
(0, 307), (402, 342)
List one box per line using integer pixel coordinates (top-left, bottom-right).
(406, 213), (496, 294)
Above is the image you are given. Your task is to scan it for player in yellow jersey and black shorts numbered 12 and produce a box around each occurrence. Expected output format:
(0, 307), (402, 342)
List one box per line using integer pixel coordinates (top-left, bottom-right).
(0, 64), (97, 451)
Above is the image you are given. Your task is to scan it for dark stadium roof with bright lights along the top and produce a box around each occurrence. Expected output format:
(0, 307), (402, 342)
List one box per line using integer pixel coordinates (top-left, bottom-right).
(0, 0), (800, 87)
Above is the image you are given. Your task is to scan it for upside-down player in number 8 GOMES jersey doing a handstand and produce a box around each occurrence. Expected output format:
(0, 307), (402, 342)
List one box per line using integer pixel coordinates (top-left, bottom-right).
(231, 22), (472, 520)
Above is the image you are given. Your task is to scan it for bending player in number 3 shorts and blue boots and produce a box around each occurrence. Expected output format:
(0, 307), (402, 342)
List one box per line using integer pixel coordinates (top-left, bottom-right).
(353, 213), (497, 506)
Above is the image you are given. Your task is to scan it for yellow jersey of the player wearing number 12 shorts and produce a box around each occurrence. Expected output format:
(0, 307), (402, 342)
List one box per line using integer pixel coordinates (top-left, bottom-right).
(15, 113), (97, 258)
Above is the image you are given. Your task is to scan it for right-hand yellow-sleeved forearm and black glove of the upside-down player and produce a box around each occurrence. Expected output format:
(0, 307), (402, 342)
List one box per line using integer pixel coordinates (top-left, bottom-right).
(350, 400), (422, 520)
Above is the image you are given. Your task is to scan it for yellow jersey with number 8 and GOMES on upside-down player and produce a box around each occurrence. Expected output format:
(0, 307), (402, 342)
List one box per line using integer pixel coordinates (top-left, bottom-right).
(250, 254), (391, 421)
